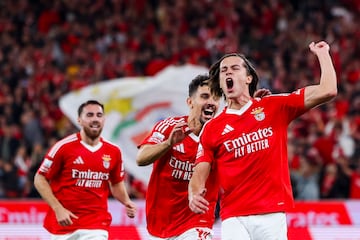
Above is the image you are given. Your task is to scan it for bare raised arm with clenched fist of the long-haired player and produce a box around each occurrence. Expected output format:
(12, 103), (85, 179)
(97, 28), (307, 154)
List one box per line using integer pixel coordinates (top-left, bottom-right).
(305, 41), (337, 109)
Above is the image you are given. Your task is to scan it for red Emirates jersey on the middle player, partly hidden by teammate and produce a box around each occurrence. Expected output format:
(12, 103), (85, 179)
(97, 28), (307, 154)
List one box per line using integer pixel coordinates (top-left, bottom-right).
(141, 116), (218, 238)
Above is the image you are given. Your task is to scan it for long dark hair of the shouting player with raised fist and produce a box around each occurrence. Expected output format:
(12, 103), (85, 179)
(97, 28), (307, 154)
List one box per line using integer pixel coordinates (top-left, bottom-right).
(209, 53), (259, 97)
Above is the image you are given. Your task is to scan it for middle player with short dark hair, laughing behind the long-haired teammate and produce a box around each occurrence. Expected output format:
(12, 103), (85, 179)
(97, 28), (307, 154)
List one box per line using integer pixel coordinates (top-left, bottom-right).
(136, 75), (220, 240)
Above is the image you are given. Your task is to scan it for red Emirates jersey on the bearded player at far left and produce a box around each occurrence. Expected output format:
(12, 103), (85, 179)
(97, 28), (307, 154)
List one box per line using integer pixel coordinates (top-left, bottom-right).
(38, 133), (124, 234)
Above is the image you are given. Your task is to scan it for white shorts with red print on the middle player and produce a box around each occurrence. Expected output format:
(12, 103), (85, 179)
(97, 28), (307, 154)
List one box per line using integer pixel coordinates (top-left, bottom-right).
(150, 227), (214, 240)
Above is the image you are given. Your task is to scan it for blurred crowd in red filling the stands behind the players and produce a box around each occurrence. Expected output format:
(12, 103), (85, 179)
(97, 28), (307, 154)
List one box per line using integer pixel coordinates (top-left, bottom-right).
(0, 0), (360, 200)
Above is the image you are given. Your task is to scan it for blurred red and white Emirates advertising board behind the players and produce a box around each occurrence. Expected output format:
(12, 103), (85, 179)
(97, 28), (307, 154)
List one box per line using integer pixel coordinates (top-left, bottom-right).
(0, 199), (360, 240)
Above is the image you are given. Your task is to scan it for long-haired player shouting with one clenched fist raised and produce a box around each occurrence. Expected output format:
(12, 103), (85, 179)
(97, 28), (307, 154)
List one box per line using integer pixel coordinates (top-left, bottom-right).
(189, 41), (337, 240)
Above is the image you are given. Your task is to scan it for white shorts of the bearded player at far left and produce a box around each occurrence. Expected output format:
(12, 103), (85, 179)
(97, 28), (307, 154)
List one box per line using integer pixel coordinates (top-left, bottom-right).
(51, 229), (109, 240)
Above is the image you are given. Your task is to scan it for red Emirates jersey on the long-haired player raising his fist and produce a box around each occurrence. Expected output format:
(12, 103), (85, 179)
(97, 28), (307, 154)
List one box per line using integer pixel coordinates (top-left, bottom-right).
(196, 89), (306, 220)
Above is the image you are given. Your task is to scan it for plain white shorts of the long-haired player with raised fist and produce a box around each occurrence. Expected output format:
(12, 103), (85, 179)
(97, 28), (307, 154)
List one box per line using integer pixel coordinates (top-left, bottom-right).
(221, 213), (287, 240)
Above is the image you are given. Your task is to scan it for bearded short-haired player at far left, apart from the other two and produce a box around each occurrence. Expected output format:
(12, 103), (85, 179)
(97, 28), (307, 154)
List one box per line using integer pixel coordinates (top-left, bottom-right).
(34, 100), (136, 240)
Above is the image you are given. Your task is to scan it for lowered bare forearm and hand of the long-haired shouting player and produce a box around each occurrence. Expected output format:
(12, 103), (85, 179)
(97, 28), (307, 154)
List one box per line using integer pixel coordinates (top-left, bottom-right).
(189, 162), (211, 213)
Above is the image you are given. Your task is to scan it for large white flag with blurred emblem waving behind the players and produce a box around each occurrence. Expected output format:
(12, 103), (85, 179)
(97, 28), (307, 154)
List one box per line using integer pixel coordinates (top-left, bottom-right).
(59, 65), (208, 185)
